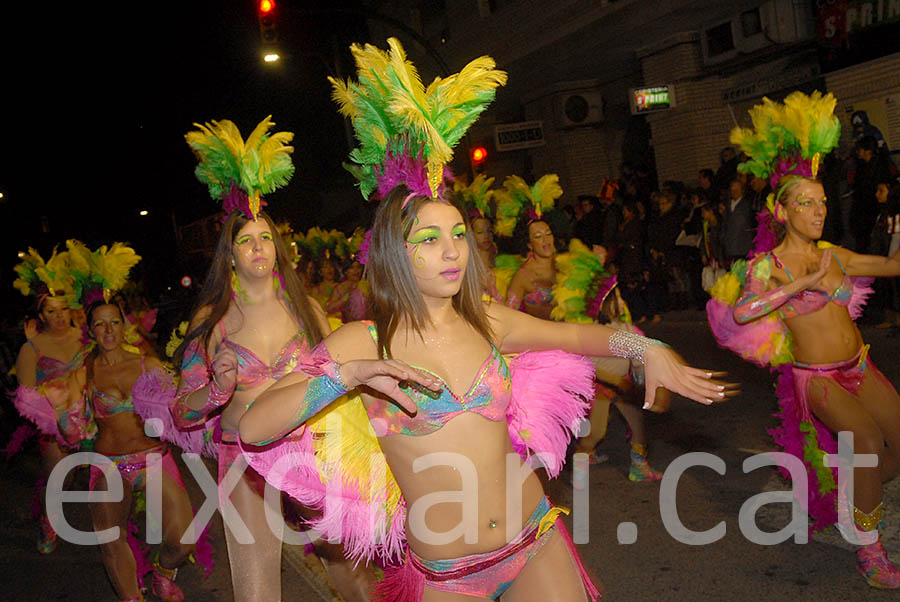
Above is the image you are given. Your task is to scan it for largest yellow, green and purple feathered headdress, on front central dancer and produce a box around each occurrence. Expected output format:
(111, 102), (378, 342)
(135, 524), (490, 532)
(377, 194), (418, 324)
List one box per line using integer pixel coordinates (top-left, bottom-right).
(328, 38), (506, 200)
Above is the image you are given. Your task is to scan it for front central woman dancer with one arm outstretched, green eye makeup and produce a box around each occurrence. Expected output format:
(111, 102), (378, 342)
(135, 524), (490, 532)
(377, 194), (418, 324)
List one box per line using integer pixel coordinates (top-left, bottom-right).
(240, 39), (740, 600)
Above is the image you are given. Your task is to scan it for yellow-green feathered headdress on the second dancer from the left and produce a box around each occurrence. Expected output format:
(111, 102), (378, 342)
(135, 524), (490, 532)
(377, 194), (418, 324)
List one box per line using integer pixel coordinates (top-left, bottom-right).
(66, 239), (141, 307)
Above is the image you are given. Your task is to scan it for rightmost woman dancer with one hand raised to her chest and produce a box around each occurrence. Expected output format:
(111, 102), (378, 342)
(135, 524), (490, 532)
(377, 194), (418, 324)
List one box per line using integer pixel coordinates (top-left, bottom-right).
(708, 92), (900, 589)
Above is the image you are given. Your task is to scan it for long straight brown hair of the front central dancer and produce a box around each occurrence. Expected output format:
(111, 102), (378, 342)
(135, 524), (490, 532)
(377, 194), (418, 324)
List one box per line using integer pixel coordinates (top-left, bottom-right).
(366, 185), (492, 358)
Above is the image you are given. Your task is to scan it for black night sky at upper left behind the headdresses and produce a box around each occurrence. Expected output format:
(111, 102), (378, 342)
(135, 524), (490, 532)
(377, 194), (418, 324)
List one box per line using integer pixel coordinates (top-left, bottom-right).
(0, 0), (368, 308)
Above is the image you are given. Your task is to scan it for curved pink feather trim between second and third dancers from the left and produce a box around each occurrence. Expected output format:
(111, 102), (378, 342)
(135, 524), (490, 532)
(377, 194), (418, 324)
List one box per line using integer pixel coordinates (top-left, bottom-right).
(131, 367), (218, 458)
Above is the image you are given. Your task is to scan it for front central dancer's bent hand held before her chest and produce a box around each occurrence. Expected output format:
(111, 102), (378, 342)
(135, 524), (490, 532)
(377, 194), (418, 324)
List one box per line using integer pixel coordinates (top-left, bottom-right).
(340, 360), (441, 414)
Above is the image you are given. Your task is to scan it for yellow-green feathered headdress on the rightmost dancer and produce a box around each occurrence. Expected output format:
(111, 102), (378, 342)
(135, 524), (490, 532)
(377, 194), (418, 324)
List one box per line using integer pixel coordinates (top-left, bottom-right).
(731, 91), (841, 195)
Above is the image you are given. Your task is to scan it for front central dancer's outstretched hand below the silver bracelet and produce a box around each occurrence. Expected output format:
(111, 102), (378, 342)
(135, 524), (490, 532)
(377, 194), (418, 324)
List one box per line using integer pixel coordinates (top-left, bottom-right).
(644, 345), (740, 412)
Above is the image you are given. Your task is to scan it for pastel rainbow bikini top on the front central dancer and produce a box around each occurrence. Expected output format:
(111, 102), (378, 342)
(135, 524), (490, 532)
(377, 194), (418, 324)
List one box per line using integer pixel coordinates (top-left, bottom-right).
(366, 322), (511, 437)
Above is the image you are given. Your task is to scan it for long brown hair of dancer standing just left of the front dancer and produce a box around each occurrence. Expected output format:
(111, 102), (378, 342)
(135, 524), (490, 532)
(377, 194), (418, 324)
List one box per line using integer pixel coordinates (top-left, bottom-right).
(173, 210), (324, 366)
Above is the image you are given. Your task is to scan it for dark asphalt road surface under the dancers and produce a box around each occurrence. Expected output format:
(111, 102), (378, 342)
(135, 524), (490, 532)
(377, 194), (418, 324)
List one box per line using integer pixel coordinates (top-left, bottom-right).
(0, 311), (900, 602)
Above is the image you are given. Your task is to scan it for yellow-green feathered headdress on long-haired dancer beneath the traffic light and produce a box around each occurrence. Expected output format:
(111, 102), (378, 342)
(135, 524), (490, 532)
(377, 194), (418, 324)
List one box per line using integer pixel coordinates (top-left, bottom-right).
(185, 115), (294, 220)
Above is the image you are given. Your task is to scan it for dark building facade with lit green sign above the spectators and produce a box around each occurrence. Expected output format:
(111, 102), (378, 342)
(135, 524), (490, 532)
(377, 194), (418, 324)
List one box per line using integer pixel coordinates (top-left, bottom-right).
(370, 0), (900, 202)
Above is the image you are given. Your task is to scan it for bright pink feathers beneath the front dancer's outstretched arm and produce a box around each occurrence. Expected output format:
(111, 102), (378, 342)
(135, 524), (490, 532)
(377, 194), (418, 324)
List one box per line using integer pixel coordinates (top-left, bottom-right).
(506, 351), (594, 477)
